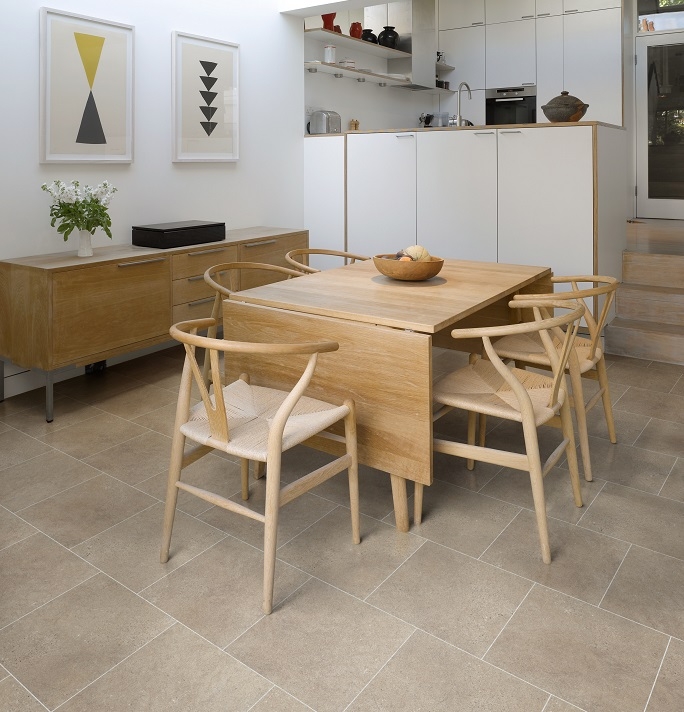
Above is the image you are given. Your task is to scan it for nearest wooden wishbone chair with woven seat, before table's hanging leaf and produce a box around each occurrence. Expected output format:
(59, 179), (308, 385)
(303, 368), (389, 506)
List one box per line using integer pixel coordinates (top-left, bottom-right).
(161, 319), (360, 614)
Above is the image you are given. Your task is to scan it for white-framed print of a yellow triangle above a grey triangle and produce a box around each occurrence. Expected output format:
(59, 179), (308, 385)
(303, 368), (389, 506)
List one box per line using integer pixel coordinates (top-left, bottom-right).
(40, 7), (133, 163)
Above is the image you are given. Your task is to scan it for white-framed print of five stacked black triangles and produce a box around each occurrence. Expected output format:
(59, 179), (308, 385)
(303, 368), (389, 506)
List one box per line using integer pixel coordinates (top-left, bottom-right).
(171, 32), (239, 162)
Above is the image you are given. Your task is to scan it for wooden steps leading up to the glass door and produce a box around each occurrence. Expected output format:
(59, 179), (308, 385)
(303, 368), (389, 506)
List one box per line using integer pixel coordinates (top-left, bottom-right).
(605, 220), (684, 364)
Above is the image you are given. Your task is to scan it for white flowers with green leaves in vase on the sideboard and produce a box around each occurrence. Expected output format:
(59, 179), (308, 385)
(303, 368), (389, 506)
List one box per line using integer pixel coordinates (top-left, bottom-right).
(40, 180), (117, 242)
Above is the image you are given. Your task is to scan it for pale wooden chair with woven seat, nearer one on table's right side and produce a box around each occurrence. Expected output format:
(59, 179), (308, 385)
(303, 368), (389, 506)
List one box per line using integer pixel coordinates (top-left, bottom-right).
(414, 295), (584, 564)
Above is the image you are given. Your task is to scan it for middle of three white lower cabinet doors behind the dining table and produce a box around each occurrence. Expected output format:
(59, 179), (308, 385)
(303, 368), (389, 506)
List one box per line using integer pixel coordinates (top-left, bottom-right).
(417, 130), (497, 262)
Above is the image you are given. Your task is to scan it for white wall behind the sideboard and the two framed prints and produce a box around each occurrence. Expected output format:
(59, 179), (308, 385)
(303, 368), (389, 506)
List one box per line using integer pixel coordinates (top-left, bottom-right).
(0, 0), (304, 259)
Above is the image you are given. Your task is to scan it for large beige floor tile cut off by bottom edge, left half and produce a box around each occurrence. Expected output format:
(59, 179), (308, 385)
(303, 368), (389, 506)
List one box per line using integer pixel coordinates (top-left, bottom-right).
(60, 624), (271, 712)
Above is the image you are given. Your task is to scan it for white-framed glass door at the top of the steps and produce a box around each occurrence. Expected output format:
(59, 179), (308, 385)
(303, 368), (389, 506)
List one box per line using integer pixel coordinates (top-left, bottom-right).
(636, 31), (684, 214)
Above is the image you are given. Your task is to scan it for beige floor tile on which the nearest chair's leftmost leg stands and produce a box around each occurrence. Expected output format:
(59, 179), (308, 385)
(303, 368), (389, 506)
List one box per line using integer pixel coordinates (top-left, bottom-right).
(72, 504), (225, 591)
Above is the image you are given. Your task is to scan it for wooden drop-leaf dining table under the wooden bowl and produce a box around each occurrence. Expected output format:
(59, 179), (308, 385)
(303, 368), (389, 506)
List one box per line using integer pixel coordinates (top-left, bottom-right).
(223, 260), (553, 531)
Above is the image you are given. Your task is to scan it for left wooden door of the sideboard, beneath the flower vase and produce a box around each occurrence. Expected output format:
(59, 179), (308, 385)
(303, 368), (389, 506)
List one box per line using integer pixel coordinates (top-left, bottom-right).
(52, 257), (171, 367)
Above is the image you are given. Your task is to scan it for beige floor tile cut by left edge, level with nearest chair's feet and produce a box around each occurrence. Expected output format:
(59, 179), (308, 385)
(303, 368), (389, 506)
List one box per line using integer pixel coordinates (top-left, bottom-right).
(0, 533), (97, 628)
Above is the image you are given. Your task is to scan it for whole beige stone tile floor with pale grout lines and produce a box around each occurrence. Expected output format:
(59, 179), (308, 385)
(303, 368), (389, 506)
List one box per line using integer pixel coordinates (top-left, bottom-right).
(0, 349), (684, 712)
